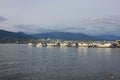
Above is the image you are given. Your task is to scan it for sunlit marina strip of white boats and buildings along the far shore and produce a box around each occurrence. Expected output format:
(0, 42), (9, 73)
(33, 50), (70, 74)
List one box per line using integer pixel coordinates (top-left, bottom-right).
(28, 39), (120, 48)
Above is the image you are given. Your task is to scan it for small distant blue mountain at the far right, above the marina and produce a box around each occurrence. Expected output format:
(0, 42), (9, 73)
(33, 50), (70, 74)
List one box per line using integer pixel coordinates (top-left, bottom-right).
(94, 35), (120, 41)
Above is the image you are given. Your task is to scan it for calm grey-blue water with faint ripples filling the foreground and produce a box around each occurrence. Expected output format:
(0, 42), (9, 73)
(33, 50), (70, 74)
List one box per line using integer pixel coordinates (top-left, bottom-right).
(0, 44), (120, 80)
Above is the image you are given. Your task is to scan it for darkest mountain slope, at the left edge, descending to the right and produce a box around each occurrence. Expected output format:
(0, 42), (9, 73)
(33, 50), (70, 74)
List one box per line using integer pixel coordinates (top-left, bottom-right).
(0, 30), (34, 40)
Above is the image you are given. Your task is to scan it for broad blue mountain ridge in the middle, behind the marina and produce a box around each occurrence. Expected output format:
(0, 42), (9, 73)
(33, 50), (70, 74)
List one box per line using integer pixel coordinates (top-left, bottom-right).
(31, 32), (98, 40)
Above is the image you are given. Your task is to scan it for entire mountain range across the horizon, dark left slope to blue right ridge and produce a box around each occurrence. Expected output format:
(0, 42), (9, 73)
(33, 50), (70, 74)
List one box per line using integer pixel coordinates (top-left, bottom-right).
(0, 30), (120, 42)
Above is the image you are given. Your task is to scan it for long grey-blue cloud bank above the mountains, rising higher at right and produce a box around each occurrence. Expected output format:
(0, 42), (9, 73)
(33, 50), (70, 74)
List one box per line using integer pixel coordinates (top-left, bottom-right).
(14, 17), (120, 35)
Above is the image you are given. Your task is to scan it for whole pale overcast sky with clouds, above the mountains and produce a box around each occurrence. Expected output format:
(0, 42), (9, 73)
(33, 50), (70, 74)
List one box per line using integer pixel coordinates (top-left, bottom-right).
(0, 0), (120, 35)
